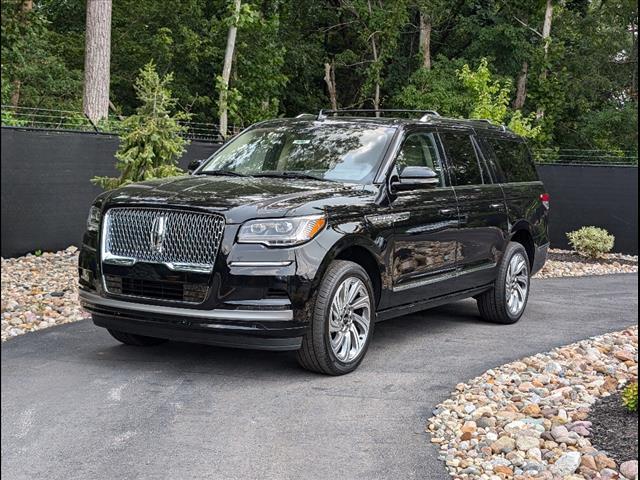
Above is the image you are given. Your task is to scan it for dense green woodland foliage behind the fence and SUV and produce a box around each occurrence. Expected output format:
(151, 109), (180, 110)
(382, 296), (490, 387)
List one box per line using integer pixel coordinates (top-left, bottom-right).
(2, 0), (638, 153)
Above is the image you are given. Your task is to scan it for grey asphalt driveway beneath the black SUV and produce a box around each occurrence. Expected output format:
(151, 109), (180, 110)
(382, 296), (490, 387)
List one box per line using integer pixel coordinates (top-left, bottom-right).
(2, 275), (638, 480)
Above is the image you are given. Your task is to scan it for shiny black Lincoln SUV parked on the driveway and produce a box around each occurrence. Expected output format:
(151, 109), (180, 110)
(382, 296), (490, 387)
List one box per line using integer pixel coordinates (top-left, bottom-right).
(79, 110), (549, 375)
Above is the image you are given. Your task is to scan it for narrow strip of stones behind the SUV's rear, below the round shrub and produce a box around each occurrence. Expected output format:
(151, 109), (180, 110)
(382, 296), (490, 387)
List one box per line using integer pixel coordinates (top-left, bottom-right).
(535, 248), (638, 278)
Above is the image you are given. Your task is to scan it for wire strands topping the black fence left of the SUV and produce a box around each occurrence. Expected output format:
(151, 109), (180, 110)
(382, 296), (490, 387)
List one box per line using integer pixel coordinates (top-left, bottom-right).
(0, 105), (242, 142)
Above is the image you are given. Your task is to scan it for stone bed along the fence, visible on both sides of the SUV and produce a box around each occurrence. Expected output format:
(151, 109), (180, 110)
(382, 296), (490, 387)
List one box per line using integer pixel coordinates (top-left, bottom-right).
(2, 247), (638, 341)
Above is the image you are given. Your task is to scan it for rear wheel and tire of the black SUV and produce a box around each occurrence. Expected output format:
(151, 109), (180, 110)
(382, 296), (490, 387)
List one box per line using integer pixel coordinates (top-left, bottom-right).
(476, 242), (530, 325)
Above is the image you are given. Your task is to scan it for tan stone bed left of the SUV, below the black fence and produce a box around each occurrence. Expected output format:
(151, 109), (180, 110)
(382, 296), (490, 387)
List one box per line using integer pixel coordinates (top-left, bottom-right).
(1, 247), (88, 342)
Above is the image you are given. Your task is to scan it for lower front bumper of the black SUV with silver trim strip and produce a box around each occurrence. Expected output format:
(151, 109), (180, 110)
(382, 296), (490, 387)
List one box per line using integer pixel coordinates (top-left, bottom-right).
(79, 290), (305, 350)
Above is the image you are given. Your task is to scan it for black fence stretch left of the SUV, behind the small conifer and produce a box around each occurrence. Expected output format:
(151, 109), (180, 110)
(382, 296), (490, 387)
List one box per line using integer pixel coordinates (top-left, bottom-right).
(1, 127), (220, 257)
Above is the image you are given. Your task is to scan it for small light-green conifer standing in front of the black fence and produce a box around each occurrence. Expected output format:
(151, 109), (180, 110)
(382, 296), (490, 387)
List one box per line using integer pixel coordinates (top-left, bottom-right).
(91, 62), (188, 190)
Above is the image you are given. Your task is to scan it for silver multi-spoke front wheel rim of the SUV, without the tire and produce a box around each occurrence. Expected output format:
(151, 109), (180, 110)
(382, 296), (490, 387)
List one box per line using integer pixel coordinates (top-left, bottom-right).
(329, 277), (371, 362)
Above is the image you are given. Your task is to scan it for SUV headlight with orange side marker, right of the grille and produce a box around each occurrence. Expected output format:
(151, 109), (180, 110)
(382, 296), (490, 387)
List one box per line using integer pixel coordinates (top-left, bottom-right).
(238, 215), (326, 247)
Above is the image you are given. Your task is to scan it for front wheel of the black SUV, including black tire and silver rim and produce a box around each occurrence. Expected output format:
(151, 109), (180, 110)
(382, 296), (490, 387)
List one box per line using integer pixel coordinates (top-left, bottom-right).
(297, 260), (375, 375)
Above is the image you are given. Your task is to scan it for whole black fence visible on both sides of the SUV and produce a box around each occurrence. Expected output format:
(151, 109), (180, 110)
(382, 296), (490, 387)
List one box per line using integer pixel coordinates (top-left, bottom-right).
(1, 127), (638, 257)
